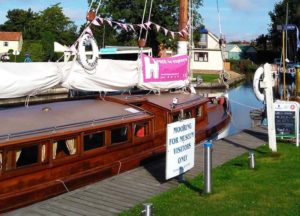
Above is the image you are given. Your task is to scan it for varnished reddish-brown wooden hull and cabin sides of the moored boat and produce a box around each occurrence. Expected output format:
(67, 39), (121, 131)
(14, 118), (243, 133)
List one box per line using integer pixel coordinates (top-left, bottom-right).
(0, 95), (230, 212)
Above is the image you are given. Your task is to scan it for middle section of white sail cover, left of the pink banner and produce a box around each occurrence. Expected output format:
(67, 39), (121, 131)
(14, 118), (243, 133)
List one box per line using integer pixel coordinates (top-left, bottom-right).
(62, 59), (138, 92)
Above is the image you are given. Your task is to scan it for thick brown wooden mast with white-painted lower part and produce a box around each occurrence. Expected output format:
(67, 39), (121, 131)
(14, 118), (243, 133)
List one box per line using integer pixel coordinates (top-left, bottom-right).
(178, 0), (188, 54)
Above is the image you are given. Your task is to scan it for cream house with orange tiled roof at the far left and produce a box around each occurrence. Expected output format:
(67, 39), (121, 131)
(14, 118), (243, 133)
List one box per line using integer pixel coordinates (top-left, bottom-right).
(0, 32), (23, 54)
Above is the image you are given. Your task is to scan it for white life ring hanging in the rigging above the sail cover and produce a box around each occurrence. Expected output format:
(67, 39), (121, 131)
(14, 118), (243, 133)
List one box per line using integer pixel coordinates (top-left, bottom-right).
(78, 34), (98, 70)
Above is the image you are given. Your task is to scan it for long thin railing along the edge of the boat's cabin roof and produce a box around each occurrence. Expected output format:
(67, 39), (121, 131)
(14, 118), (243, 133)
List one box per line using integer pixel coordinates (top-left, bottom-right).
(0, 111), (147, 140)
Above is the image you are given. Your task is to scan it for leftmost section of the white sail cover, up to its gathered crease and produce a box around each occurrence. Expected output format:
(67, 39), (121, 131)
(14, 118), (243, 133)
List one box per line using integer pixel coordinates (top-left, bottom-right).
(0, 62), (62, 98)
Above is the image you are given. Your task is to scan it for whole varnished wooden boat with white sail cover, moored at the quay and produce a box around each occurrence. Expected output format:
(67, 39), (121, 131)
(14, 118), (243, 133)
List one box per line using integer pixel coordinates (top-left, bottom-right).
(0, 0), (230, 212)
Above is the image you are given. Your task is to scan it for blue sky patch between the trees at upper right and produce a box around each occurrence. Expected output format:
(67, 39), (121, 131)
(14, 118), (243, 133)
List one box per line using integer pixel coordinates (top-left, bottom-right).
(200, 0), (279, 41)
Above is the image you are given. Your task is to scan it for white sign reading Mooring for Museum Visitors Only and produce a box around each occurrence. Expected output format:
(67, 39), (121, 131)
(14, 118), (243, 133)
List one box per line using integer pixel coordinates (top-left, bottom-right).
(166, 118), (195, 179)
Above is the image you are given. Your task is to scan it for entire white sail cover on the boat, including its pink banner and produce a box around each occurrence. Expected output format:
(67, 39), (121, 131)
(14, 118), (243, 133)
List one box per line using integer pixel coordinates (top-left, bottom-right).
(0, 56), (188, 99)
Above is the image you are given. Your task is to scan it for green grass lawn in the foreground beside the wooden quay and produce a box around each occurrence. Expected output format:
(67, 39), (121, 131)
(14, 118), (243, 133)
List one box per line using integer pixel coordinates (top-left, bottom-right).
(121, 144), (300, 216)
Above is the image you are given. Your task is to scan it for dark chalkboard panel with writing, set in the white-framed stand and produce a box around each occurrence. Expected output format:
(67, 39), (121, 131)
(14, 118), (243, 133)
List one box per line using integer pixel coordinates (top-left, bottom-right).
(275, 111), (296, 138)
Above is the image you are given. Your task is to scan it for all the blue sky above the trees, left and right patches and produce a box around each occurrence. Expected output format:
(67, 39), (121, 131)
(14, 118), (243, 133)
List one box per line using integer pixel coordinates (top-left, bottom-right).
(0, 0), (278, 41)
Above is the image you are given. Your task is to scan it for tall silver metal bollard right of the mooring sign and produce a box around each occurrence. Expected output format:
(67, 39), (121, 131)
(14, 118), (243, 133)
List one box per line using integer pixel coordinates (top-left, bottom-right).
(203, 141), (213, 194)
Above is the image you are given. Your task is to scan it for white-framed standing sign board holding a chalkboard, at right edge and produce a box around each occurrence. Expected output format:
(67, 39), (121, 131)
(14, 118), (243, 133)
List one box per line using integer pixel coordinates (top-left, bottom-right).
(274, 100), (299, 146)
